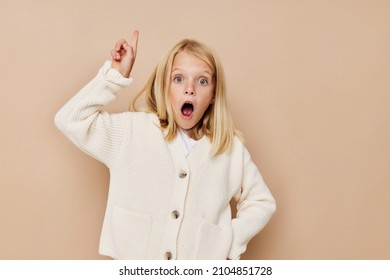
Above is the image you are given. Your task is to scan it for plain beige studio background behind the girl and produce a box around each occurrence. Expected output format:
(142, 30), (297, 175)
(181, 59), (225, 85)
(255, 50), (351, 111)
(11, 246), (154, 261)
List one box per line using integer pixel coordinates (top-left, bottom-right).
(0, 0), (390, 259)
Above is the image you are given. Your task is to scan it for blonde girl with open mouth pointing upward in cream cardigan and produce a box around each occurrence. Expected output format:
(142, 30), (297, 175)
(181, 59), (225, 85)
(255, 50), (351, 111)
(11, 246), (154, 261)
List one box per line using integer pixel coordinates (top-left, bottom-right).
(55, 31), (275, 260)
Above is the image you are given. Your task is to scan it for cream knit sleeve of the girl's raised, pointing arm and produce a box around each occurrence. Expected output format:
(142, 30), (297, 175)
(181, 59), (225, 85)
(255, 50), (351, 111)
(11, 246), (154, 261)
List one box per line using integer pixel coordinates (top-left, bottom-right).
(54, 61), (132, 167)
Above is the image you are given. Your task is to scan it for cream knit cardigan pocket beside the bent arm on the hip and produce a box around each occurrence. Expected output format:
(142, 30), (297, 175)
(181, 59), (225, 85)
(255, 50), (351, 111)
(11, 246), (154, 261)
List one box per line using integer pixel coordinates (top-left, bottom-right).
(195, 220), (233, 260)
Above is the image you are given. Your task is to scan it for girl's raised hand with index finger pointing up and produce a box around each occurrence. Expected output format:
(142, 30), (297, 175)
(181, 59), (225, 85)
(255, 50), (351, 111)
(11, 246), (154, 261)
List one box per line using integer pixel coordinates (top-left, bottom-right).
(111, 30), (139, 78)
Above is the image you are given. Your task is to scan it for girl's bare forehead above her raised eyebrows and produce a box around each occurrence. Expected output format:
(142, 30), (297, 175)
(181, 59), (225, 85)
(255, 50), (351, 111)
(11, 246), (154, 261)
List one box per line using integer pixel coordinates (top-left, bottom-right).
(172, 51), (214, 75)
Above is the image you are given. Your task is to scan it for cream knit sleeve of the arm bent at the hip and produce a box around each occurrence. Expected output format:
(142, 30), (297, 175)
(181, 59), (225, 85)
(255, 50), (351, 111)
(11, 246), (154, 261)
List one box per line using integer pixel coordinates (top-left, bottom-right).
(228, 148), (276, 260)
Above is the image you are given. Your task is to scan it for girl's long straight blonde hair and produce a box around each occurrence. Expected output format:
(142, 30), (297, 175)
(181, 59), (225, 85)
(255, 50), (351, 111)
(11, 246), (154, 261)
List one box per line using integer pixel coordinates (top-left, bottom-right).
(130, 39), (242, 155)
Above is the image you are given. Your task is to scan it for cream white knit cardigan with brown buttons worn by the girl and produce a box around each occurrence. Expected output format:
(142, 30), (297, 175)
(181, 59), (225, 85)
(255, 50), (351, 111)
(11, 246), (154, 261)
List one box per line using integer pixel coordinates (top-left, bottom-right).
(55, 61), (276, 259)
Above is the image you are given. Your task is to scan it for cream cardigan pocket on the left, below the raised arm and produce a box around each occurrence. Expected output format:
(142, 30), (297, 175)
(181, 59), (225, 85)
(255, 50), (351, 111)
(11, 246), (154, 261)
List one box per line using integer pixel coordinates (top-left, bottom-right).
(111, 206), (152, 260)
